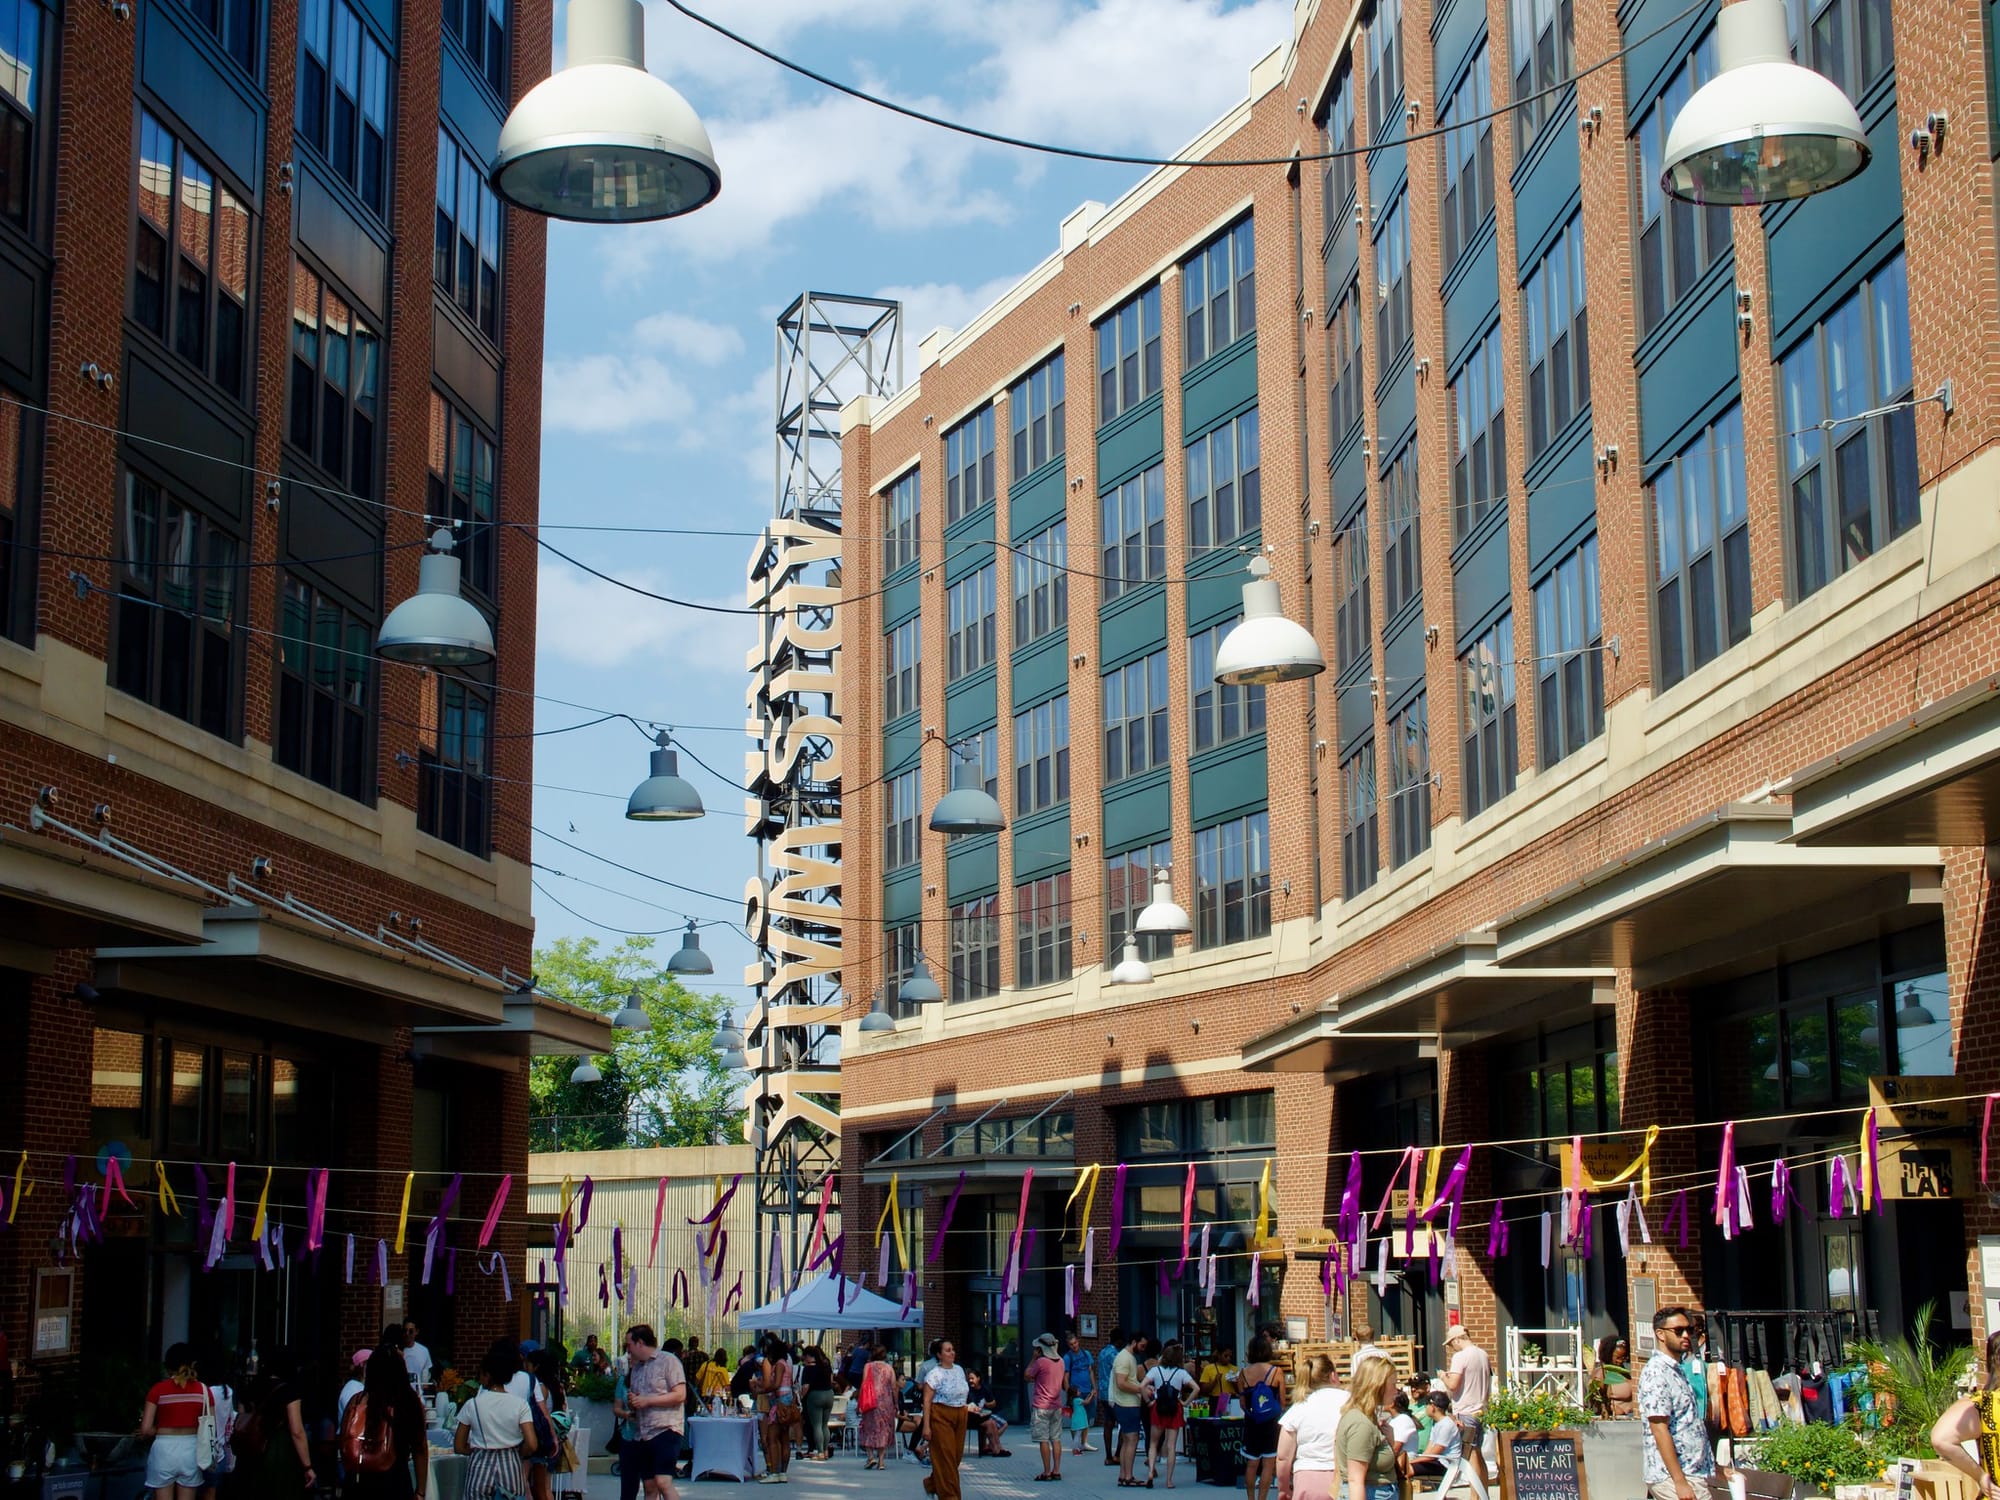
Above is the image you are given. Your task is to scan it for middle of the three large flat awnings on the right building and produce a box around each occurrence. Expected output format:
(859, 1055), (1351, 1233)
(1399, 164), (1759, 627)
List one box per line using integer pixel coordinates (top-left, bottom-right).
(1496, 804), (1942, 990)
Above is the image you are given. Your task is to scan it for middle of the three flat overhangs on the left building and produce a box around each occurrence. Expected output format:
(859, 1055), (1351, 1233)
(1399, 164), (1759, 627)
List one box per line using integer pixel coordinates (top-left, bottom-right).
(96, 906), (510, 1042)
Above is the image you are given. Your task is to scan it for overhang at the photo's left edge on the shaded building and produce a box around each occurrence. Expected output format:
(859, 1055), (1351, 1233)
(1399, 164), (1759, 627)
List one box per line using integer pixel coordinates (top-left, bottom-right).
(0, 824), (216, 974)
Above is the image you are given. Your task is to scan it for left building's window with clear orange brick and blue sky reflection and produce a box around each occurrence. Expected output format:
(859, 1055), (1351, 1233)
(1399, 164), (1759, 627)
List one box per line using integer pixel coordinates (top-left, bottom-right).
(132, 110), (250, 400)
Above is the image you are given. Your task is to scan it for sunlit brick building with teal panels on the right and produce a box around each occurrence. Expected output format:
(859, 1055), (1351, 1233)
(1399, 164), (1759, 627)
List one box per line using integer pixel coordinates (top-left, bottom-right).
(842, 0), (2000, 1424)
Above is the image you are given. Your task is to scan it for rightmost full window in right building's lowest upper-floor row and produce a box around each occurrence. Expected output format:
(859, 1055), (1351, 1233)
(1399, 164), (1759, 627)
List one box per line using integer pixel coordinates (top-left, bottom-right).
(1778, 250), (1920, 598)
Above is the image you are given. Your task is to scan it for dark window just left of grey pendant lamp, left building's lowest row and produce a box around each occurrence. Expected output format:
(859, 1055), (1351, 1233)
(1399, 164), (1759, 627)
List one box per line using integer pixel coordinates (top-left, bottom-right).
(274, 574), (376, 802)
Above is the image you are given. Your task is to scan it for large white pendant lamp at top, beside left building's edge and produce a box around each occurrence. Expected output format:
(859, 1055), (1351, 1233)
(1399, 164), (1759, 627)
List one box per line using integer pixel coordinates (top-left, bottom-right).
(492, 0), (722, 224)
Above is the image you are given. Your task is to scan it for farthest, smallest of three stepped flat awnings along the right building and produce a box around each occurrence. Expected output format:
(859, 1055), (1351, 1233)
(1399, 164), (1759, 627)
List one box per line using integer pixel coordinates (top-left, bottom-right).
(1240, 932), (1616, 1078)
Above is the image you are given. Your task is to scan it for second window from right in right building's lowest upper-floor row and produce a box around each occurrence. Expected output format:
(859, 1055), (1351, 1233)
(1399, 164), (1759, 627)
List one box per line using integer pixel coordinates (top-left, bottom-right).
(1650, 406), (1750, 688)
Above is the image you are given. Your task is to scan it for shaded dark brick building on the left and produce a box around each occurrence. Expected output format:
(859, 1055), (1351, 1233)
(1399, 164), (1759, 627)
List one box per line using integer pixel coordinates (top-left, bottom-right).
(0, 0), (608, 1422)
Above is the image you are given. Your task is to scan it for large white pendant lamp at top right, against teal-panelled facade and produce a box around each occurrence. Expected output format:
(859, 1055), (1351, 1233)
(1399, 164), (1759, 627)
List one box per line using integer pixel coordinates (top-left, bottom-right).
(1660, 0), (1870, 208)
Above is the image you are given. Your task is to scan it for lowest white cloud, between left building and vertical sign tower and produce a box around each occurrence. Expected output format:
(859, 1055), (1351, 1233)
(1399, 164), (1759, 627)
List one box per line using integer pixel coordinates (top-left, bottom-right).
(536, 560), (756, 680)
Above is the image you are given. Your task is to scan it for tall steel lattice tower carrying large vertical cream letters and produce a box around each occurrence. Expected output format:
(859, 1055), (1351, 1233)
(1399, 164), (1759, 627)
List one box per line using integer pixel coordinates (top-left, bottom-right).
(744, 292), (902, 1302)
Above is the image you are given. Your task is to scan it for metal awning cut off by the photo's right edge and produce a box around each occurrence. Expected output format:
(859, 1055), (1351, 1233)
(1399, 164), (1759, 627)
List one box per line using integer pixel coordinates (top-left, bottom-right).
(1788, 678), (2000, 848)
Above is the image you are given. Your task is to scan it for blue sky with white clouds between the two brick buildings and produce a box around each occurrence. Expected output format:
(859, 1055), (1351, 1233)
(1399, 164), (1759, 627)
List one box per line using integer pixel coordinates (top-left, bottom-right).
(534, 0), (1292, 1000)
